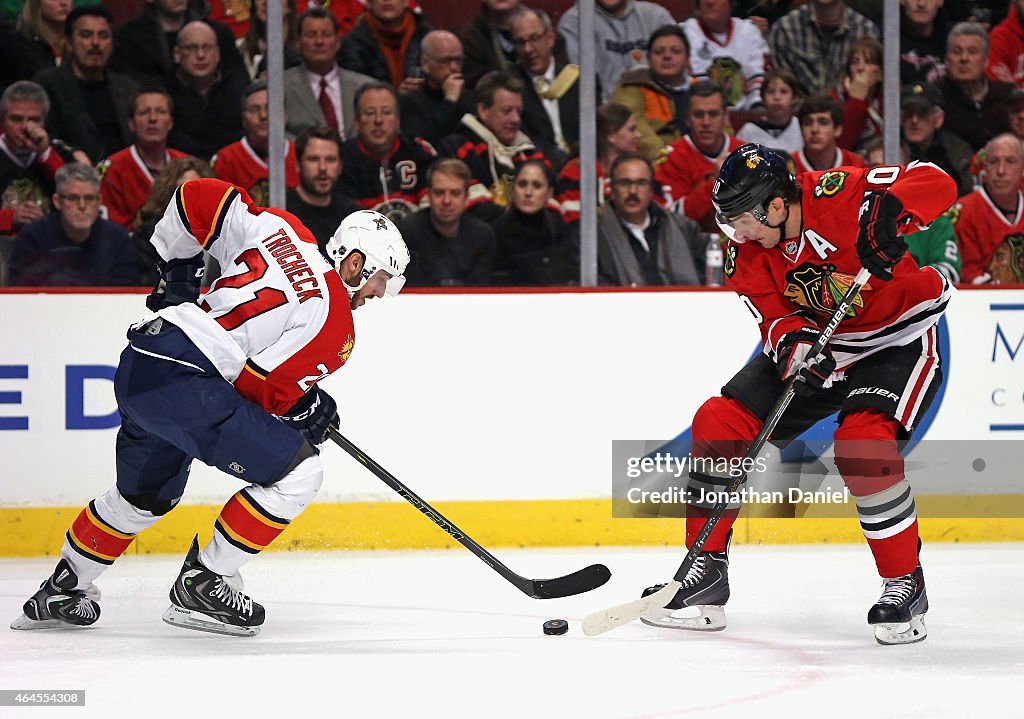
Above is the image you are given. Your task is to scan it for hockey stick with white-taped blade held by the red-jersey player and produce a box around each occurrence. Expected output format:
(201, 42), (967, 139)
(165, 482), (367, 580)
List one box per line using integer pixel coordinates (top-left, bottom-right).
(583, 267), (870, 636)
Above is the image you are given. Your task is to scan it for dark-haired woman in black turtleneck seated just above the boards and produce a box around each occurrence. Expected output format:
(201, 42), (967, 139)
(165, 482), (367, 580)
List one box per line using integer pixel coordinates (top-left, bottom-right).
(494, 160), (579, 287)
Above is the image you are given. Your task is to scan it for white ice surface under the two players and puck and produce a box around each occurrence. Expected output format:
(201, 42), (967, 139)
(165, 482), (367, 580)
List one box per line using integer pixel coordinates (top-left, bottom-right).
(0, 544), (1024, 719)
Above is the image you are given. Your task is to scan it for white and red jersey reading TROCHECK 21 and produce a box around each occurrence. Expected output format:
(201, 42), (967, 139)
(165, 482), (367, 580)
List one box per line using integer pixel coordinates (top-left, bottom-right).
(151, 179), (355, 416)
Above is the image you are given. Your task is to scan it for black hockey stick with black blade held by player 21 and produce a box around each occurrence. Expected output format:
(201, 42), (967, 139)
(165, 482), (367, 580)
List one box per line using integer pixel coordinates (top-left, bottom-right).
(328, 429), (611, 599)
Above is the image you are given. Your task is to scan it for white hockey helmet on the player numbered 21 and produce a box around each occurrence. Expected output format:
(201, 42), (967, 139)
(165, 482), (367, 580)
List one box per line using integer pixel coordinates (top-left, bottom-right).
(325, 210), (409, 297)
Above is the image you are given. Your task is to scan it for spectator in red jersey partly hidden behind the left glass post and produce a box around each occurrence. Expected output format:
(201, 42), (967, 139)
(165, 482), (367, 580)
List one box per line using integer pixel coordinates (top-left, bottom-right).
(210, 80), (299, 207)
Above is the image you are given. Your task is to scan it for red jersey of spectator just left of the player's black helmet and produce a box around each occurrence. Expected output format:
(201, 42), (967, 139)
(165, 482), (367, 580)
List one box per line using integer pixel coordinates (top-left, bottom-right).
(654, 135), (743, 226)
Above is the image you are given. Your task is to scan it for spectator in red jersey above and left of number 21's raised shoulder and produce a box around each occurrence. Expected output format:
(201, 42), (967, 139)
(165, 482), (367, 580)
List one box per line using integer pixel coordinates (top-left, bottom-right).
(97, 88), (188, 229)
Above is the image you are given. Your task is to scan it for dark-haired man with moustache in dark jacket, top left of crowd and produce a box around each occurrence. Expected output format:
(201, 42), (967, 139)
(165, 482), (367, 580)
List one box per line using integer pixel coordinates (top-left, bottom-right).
(35, 6), (138, 163)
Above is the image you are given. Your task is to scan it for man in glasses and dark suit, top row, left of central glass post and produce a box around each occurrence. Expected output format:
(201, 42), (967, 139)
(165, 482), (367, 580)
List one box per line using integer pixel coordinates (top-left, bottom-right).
(512, 8), (581, 158)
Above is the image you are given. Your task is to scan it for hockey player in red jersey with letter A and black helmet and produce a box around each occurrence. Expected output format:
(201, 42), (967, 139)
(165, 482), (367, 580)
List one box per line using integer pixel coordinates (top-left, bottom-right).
(643, 144), (956, 644)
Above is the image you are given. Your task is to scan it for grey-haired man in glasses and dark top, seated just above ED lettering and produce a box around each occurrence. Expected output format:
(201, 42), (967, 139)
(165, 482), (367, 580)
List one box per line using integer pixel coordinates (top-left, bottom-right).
(10, 163), (139, 287)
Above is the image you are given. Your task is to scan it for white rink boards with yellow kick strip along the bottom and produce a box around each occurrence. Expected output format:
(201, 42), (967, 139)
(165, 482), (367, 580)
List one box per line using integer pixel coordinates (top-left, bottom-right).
(0, 290), (1024, 555)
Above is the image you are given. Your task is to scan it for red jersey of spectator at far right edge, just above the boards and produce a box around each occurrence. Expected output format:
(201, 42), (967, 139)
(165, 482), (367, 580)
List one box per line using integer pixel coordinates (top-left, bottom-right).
(949, 187), (1024, 283)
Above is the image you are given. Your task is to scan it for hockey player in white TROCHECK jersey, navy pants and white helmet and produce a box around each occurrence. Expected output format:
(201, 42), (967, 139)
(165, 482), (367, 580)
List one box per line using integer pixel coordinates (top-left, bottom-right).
(11, 179), (409, 635)
